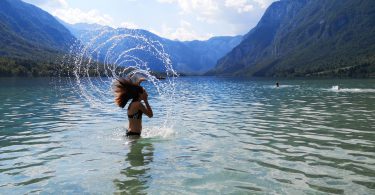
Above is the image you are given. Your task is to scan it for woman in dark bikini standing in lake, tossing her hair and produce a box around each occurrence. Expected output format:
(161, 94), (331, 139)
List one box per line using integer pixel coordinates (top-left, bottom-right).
(114, 78), (153, 136)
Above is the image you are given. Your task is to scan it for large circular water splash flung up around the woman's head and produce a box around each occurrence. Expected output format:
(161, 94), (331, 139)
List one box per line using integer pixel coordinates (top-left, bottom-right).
(61, 28), (177, 134)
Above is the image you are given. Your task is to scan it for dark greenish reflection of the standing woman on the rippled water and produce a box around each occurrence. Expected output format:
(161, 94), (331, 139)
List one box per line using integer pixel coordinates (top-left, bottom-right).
(114, 139), (154, 194)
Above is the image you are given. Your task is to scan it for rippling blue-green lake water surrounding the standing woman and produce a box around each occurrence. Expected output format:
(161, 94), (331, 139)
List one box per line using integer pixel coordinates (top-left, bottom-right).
(0, 77), (375, 194)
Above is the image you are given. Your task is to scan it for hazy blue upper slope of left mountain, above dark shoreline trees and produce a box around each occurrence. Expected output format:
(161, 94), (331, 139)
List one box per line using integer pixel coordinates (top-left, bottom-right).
(0, 0), (74, 58)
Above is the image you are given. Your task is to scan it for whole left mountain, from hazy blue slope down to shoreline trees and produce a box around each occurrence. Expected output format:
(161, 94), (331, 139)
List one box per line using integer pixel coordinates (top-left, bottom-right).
(0, 0), (75, 76)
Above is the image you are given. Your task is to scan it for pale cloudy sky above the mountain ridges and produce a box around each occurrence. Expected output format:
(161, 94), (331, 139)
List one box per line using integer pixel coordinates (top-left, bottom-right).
(23, 0), (276, 41)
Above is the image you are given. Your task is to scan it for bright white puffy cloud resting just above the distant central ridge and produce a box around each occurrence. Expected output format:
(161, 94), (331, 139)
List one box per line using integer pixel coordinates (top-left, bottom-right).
(150, 20), (213, 41)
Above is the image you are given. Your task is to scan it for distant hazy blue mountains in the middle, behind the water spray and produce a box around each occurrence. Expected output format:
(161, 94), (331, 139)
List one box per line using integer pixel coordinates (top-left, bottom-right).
(65, 23), (242, 74)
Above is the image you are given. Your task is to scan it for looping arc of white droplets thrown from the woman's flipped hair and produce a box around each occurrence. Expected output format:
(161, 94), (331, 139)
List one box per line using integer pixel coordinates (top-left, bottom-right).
(62, 27), (177, 127)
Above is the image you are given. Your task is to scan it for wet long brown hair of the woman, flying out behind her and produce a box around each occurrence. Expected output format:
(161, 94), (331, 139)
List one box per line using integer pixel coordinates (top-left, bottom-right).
(113, 78), (143, 108)
